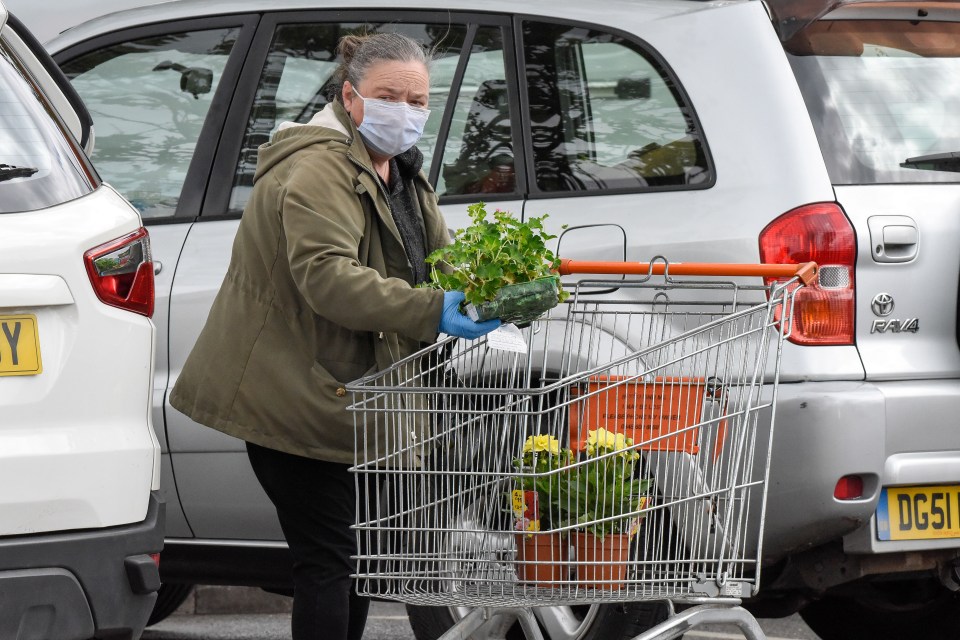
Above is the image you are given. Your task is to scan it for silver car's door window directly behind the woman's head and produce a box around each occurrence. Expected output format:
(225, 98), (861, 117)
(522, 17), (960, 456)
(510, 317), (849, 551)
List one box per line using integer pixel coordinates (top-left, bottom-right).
(229, 22), (466, 213)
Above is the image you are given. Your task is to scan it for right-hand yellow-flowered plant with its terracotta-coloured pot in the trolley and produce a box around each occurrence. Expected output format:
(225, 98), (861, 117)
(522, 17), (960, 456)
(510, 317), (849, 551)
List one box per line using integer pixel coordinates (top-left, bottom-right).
(565, 429), (649, 589)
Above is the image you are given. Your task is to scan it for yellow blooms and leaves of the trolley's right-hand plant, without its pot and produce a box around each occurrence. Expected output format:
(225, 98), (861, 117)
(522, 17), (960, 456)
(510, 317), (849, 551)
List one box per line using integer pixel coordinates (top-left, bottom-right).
(563, 429), (650, 538)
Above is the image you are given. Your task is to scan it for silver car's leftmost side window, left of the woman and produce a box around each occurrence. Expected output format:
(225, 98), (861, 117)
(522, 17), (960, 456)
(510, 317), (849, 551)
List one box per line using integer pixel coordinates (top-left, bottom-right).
(61, 28), (240, 218)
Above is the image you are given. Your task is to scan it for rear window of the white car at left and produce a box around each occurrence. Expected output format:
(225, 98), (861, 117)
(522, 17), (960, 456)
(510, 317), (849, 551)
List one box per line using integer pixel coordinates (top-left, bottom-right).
(0, 43), (93, 213)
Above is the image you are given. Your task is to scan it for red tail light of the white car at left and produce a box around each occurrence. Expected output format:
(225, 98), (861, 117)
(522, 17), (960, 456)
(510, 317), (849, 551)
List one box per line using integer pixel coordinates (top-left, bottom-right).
(83, 227), (154, 318)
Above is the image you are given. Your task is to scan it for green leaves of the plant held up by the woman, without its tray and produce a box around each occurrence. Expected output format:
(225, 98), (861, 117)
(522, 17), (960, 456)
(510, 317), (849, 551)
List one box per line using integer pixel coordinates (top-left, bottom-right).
(427, 202), (569, 305)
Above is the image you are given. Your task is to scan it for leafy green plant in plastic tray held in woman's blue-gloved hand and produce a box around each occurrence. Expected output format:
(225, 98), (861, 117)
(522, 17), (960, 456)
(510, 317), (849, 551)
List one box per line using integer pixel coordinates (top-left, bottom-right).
(427, 202), (569, 325)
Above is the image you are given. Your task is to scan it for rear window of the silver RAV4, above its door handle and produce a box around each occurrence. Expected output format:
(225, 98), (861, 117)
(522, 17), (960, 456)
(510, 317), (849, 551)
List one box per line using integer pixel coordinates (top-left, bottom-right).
(785, 20), (960, 184)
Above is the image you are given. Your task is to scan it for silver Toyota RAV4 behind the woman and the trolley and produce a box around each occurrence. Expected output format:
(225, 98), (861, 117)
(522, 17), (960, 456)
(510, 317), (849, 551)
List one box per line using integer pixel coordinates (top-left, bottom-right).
(41, 0), (960, 640)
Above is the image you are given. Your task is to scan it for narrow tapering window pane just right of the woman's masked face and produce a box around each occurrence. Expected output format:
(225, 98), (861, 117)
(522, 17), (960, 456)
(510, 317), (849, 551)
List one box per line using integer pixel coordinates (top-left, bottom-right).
(437, 27), (516, 195)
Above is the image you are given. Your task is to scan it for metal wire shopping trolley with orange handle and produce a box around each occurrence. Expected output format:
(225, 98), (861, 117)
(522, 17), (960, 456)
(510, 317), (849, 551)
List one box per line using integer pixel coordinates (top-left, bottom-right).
(347, 258), (817, 640)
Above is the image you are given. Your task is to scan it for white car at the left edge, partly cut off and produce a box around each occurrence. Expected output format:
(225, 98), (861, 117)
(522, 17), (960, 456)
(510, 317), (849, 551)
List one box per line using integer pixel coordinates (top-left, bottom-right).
(0, 3), (164, 640)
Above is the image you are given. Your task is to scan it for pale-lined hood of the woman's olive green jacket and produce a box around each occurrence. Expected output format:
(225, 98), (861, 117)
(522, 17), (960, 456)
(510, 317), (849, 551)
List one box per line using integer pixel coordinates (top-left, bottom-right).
(253, 101), (356, 181)
